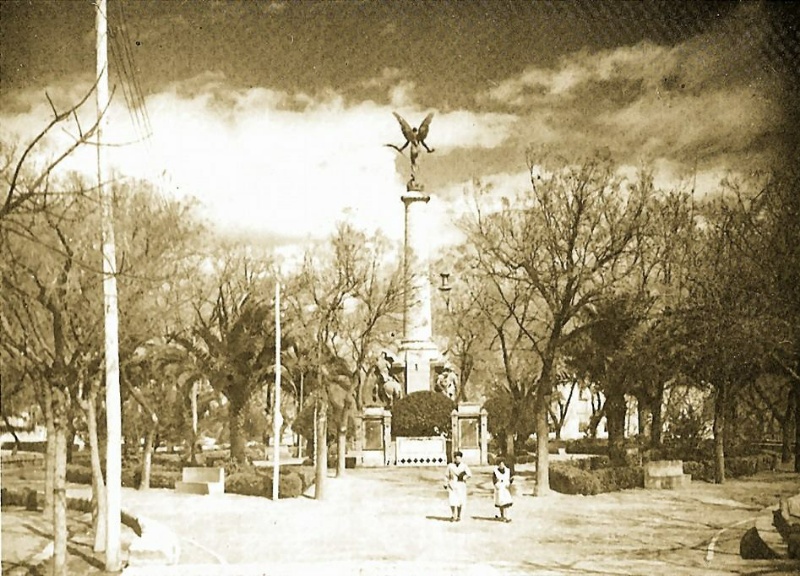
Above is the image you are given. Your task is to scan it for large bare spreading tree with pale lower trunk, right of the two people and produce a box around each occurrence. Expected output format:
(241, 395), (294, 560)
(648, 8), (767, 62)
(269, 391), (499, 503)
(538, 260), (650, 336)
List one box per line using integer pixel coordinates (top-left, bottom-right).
(465, 153), (652, 495)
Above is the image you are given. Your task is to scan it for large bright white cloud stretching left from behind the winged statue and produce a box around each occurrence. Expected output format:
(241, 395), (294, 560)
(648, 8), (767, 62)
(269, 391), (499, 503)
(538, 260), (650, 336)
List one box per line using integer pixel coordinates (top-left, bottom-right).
(0, 73), (513, 245)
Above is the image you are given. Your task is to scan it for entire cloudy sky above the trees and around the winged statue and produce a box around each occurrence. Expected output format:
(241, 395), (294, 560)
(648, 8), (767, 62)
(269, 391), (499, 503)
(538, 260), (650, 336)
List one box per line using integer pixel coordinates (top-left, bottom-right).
(0, 0), (800, 251)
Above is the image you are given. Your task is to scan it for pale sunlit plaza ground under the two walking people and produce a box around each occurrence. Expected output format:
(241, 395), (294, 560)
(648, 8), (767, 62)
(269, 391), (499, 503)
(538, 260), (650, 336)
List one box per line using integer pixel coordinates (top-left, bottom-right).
(3, 468), (800, 576)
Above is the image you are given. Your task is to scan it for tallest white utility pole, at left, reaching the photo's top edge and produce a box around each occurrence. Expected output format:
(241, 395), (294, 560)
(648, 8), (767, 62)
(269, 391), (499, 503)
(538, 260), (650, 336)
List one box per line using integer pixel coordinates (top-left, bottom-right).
(95, 0), (122, 572)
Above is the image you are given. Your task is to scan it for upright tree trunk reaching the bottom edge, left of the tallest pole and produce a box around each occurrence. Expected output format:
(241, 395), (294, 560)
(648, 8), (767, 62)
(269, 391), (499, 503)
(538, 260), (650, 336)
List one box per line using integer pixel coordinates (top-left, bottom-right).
(53, 389), (68, 576)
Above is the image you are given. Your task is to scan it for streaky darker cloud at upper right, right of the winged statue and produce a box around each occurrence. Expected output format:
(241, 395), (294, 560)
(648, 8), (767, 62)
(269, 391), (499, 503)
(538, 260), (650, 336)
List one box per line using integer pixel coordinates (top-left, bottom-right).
(478, 5), (782, 167)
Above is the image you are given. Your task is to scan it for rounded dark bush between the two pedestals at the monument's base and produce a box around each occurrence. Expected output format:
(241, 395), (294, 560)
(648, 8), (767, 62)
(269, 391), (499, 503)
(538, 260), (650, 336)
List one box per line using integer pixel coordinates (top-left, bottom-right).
(392, 390), (456, 437)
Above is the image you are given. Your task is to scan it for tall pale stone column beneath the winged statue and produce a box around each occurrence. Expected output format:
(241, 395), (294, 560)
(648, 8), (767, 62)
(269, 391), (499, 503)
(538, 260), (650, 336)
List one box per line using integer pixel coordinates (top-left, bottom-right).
(400, 184), (439, 394)
